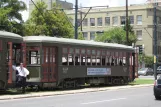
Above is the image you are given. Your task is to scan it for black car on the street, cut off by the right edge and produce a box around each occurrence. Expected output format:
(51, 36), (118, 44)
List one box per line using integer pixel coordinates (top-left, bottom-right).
(154, 76), (161, 100)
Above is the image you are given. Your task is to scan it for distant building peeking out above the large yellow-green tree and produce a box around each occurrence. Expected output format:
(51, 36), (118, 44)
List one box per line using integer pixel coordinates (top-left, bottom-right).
(29, 0), (73, 17)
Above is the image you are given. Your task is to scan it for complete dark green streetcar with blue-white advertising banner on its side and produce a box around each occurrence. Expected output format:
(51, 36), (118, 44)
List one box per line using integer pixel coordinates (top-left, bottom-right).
(23, 36), (138, 88)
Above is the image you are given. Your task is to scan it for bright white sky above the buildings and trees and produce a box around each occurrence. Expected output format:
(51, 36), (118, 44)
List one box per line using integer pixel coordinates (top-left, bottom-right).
(21, 0), (147, 21)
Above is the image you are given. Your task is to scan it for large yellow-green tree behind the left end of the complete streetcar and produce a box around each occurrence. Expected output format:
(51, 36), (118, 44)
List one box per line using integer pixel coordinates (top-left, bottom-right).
(25, 2), (74, 38)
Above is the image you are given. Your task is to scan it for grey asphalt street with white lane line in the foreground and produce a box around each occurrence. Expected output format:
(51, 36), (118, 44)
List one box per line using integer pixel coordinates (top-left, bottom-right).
(0, 86), (161, 107)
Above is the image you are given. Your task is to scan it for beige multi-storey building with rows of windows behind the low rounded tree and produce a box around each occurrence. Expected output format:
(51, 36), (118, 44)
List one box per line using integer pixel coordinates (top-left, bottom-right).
(66, 4), (161, 62)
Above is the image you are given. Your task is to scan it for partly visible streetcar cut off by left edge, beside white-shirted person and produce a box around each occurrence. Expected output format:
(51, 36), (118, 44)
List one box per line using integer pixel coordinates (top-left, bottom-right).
(0, 31), (25, 90)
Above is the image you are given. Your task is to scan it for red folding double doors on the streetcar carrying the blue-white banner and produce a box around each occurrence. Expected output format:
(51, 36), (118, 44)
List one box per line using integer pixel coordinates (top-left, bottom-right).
(42, 47), (57, 82)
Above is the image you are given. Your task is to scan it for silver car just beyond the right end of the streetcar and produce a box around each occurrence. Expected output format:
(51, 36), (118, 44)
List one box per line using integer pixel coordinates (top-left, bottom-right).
(138, 68), (154, 76)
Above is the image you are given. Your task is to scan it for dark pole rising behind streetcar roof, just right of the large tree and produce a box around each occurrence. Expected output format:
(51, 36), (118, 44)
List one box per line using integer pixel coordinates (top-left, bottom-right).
(75, 0), (78, 39)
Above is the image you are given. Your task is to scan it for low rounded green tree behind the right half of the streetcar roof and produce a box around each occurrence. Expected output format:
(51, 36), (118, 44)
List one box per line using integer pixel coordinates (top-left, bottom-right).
(95, 27), (137, 44)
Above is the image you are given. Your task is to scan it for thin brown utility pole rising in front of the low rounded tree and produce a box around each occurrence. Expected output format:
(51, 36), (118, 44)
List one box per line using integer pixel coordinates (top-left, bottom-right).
(126, 0), (129, 45)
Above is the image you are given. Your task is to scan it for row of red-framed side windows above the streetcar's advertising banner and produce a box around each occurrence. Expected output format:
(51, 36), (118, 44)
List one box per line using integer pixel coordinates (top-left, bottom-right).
(62, 48), (127, 66)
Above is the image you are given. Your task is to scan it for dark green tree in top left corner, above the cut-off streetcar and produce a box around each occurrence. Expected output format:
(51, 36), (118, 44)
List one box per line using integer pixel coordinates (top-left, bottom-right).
(0, 0), (27, 35)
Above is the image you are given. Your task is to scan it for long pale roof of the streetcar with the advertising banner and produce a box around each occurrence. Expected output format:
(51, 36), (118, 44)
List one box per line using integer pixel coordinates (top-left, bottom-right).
(23, 36), (134, 50)
